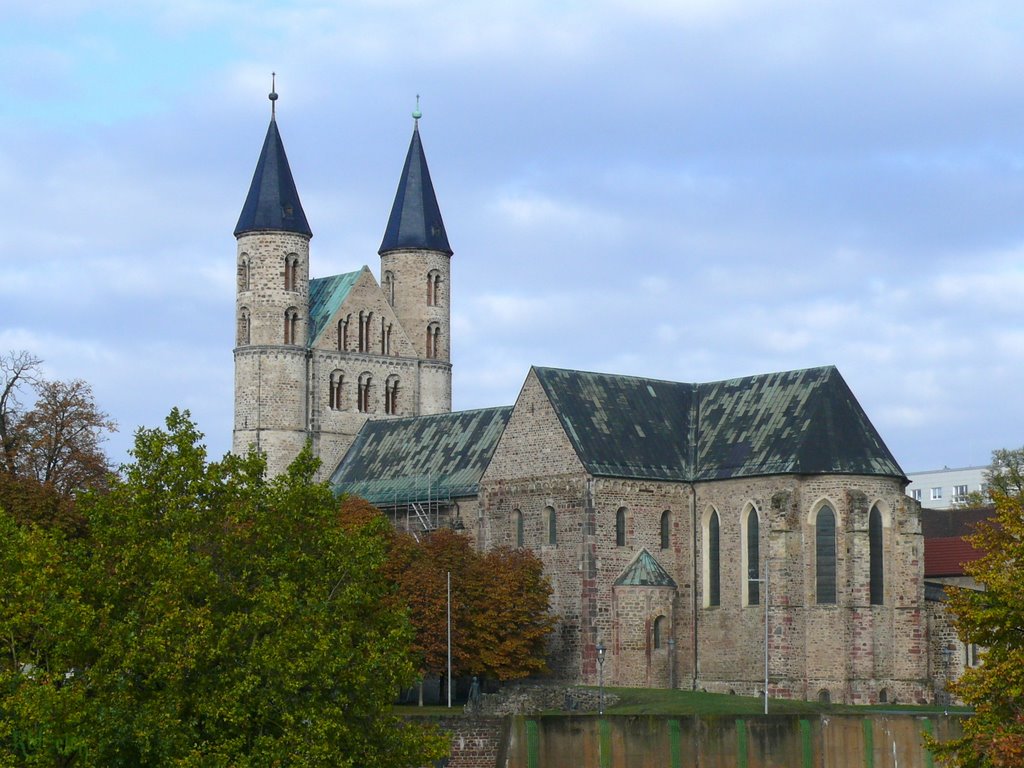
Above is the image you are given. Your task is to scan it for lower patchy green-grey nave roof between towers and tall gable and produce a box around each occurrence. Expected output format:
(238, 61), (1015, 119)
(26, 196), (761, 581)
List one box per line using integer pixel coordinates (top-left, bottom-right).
(331, 407), (512, 505)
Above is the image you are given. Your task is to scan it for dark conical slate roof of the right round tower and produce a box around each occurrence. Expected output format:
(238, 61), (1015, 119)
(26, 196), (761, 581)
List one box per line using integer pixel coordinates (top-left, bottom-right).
(378, 121), (452, 256)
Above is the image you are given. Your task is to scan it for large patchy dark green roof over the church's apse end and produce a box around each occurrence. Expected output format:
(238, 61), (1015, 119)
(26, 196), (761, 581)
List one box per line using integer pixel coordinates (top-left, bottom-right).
(534, 366), (904, 481)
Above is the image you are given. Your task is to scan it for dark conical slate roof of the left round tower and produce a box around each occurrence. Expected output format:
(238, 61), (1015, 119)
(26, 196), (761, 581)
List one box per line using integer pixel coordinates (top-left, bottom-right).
(234, 118), (312, 237)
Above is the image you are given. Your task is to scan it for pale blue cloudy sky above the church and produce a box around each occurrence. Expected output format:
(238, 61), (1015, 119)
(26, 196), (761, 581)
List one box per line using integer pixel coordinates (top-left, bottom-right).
(0, 0), (1024, 471)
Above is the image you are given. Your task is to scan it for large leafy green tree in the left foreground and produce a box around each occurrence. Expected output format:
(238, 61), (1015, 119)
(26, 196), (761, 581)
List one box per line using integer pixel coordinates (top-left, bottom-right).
(0, 411), (446, 768)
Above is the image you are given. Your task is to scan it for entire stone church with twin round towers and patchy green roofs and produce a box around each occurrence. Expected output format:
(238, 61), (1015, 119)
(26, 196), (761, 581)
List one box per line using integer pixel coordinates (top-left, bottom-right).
(233, 88), (935, 703)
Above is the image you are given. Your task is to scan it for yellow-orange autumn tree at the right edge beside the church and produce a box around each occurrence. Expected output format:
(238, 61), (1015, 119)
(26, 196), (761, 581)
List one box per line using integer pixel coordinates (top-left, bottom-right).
(932, 487), (1024, 768)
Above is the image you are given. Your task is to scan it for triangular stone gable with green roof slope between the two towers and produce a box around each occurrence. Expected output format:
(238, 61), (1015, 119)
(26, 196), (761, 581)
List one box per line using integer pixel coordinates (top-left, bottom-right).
(309, 266), (417, 357)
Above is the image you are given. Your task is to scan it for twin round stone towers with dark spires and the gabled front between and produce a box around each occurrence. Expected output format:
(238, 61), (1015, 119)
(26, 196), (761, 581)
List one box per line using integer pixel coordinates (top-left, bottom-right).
(231, 87), (452, 477)
